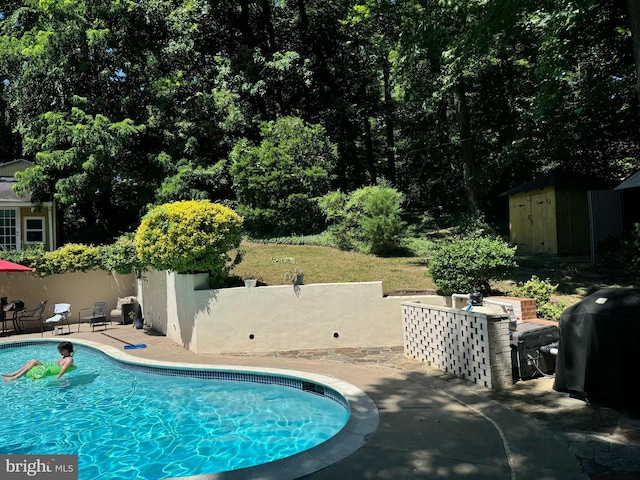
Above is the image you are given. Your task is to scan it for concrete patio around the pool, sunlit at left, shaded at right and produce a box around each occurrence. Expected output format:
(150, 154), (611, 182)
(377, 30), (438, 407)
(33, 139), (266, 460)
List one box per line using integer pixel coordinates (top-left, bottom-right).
(1, 324), (640, 480)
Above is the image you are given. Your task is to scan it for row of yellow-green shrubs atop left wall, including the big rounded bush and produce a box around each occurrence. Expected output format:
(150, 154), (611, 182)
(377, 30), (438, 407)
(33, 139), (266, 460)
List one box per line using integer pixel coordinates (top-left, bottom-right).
(2, 200), (243, 284)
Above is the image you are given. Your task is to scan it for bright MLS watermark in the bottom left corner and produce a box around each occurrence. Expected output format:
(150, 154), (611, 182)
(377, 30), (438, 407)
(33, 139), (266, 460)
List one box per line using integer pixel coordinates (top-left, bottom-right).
(0, 455), (78, 480)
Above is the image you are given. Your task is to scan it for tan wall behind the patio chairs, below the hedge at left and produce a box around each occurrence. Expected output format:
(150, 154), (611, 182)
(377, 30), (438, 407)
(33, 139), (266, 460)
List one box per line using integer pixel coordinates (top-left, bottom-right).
(0, 270), (136, 331)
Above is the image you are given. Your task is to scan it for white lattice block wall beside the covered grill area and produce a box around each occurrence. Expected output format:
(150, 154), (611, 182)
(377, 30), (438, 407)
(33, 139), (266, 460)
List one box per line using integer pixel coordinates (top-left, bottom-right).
(402, 303), (512, 389)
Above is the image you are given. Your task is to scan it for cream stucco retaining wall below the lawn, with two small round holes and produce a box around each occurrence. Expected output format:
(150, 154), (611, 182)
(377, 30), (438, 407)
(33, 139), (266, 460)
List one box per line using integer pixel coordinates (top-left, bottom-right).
(139, 272), (445, 354)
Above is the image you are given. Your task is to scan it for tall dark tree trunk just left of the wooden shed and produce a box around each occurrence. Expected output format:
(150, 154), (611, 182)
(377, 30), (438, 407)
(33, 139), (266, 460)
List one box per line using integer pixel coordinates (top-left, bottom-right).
(453, 80), (480, 215)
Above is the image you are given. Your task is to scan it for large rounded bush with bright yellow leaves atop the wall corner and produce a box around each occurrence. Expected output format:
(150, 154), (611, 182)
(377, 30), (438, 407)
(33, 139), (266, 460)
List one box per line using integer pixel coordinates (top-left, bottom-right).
(135, 200), (242, 285)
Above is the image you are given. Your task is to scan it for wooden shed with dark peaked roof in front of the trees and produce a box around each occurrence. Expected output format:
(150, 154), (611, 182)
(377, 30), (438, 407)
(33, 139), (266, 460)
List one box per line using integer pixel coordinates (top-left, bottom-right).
(503, 169), (606, 255)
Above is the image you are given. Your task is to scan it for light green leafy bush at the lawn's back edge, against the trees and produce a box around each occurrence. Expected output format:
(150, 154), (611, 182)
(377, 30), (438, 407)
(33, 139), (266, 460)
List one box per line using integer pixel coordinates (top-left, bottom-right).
(320, 182), (406, 255)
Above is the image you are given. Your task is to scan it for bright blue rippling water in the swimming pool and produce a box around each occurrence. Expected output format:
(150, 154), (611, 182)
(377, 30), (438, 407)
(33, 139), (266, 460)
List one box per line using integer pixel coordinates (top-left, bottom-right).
(0, 343), (349, 480)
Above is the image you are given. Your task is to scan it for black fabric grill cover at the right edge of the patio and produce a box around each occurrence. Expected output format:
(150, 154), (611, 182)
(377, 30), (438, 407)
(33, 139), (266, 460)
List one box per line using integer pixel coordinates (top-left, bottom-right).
(553, 288), (640, 408)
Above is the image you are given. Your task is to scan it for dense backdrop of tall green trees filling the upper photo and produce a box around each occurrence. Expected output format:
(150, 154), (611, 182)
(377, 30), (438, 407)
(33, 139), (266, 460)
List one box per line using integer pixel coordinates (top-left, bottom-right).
(0, 0), (640, 243)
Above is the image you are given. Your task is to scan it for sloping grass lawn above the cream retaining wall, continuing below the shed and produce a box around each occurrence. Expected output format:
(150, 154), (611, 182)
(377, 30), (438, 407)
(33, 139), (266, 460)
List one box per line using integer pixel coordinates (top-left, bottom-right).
(231, 241), (637, 306)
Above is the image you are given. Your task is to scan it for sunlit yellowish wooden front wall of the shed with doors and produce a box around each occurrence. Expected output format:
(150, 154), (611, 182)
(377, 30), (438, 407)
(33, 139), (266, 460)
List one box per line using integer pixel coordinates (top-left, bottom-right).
(509, 186), (558, 255)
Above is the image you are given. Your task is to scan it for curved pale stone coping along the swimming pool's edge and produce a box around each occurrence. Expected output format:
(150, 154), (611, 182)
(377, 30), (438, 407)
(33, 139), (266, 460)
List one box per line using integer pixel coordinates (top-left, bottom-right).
(0, 338), (379, 480)
